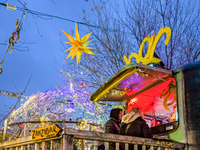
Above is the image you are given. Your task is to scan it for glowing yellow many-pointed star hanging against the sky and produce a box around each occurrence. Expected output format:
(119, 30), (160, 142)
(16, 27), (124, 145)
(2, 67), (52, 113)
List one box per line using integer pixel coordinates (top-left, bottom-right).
(63, 22), (95, 64)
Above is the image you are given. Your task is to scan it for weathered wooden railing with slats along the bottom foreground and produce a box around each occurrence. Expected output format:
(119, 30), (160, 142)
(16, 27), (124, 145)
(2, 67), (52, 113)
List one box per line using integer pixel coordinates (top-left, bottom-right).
(0, 128), (184, 150)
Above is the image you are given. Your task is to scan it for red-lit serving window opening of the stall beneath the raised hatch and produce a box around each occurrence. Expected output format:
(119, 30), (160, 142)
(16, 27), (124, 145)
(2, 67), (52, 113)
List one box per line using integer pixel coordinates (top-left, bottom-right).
(126, 77), (178, 134)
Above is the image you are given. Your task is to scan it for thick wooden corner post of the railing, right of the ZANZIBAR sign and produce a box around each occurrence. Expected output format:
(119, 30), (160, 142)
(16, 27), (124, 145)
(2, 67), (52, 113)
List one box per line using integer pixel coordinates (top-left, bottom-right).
(62, 134), (74, 150)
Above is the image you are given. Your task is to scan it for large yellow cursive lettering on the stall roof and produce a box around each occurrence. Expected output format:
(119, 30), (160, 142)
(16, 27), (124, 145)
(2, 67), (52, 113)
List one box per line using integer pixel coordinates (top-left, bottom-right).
(123, 27), (172, 65)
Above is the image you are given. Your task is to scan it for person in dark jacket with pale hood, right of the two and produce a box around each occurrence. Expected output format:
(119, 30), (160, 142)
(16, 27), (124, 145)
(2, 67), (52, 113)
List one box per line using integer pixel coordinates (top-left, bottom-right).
(120, 108), (153, 150)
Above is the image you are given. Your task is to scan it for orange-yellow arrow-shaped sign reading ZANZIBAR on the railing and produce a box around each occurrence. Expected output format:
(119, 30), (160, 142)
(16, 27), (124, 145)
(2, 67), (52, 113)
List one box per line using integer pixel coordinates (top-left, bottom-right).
(31, 124), (61, 140)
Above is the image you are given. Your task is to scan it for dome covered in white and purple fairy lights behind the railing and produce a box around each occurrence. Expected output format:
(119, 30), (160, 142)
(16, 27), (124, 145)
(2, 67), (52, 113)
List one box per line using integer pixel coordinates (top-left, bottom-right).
(6, 86), (108, 138)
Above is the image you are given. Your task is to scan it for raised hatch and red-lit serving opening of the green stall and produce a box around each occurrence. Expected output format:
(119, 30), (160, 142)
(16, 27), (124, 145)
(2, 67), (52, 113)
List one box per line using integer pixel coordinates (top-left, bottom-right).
(90, 63), (177, 134)
